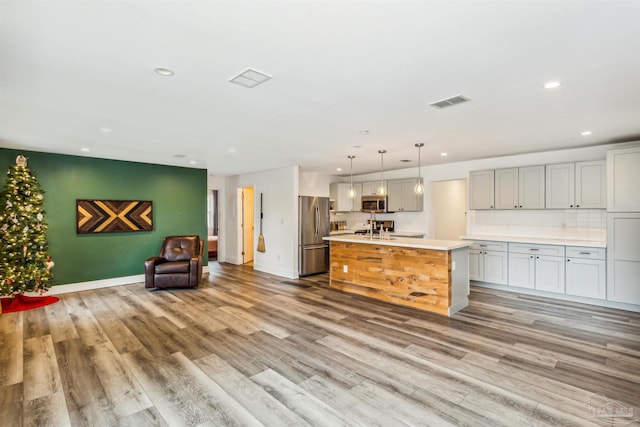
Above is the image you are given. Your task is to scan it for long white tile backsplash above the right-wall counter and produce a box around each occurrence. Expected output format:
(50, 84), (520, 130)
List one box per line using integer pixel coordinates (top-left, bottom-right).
(467, 209), (607, 242)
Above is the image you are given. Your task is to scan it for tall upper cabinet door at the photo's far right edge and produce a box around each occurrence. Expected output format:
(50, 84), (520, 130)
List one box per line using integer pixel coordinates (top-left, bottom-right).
(607, 146), (640, 212)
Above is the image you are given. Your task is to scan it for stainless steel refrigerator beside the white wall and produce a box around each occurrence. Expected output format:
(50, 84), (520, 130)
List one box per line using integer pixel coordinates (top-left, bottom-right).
(298, 196), (329, 276)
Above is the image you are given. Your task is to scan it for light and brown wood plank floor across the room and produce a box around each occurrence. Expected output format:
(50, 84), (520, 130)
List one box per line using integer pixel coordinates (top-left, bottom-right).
(0, 263), (640, 427)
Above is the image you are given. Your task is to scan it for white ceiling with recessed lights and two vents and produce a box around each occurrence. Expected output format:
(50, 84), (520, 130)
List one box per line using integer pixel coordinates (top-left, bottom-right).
(0, 0), (640, 175)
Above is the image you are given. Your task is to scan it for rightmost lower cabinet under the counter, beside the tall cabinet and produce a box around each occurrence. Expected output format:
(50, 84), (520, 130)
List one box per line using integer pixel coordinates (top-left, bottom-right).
(566, 247), (607, 299)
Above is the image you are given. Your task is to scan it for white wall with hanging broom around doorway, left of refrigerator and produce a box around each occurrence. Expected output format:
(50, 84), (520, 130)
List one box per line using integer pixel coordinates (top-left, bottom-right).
(220, 166), (300, 278)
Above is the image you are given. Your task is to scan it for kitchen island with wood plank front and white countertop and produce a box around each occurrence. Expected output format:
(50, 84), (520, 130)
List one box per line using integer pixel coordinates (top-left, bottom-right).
(324, 235), (471, 316)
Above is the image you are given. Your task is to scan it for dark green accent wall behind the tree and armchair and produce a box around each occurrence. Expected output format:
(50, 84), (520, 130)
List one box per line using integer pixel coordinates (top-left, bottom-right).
(0, 148), (207, 285)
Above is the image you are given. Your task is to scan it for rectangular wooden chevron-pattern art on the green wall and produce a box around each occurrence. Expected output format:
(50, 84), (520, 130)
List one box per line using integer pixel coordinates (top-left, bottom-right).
(76, 200), (153, 234)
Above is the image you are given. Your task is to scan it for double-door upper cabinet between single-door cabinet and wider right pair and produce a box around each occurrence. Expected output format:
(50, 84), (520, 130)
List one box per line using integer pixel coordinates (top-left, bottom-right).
(495, 166), (544, 209)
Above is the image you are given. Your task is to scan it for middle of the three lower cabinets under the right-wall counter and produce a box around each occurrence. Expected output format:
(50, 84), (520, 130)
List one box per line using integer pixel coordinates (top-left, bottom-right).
(509, 243), (565, 293)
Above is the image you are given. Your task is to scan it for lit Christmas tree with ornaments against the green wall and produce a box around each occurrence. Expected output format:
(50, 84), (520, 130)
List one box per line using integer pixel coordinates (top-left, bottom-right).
(0, 156), (53, 295)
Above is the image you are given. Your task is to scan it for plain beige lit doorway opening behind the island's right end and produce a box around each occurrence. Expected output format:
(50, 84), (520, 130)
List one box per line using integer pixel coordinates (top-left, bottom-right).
(431, 179), (467, 240)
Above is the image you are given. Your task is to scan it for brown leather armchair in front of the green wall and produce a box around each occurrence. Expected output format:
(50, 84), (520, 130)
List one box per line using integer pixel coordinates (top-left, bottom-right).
(144, 236), (204, 288)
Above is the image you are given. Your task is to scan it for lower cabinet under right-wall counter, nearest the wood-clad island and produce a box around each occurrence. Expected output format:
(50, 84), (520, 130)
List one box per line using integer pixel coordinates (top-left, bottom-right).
(469, 241), (508, 285)
